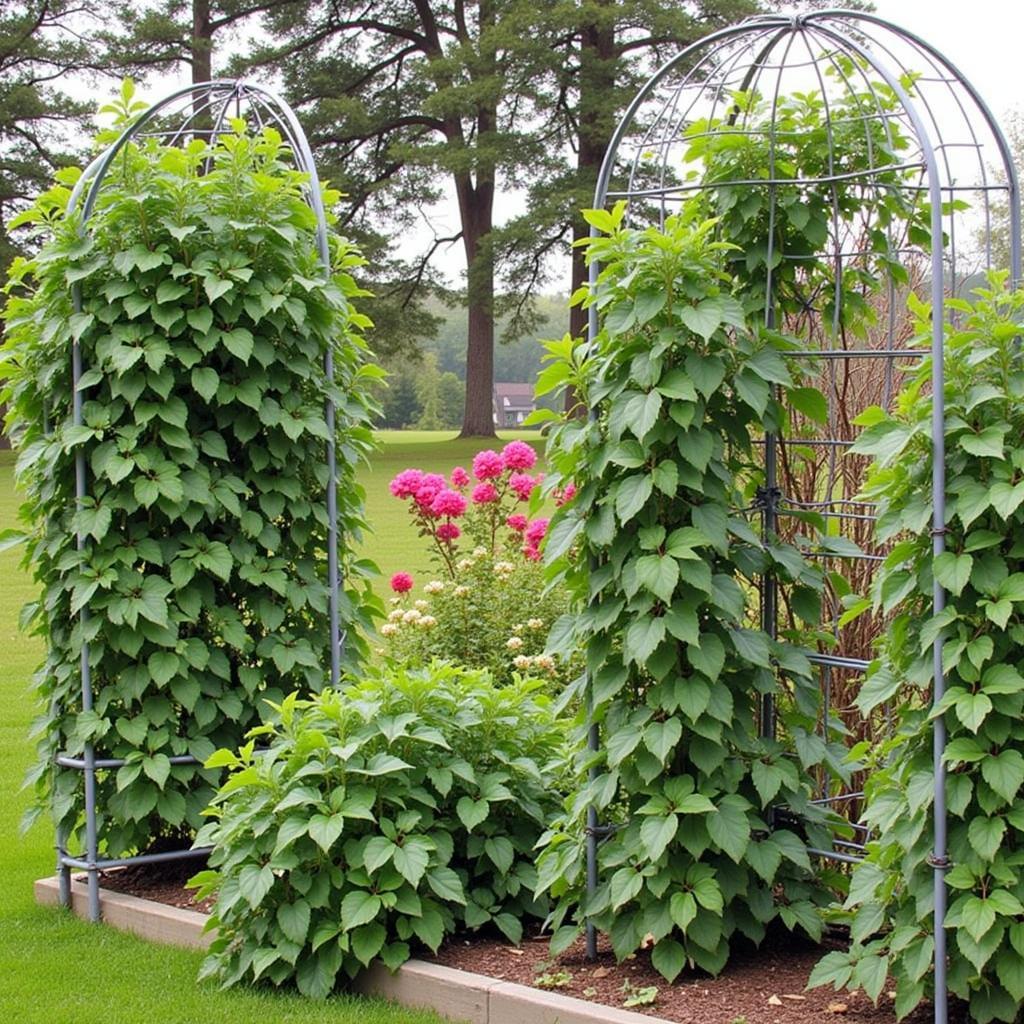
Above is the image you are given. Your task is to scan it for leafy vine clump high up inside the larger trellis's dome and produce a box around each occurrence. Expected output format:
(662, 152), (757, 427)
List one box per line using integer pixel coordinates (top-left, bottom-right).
(685, 67), (930, 323)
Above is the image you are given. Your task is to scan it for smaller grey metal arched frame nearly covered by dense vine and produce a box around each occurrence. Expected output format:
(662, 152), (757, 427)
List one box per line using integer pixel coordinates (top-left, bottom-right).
(55, 79), (344, 921)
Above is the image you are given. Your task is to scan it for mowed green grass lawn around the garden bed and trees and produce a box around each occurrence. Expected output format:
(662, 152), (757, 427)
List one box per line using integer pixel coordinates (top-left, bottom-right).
(0, 432), (538, 1024)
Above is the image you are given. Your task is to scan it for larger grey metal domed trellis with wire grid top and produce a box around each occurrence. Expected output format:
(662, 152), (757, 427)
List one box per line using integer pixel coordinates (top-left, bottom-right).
(587, 10), (1021, 1024)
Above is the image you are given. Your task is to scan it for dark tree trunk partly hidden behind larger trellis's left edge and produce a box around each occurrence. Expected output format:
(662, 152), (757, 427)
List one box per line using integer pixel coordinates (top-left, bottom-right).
(565, 0), (615, 416)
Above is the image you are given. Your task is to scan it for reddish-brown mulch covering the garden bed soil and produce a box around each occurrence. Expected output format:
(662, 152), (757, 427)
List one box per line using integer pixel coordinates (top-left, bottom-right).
(100, 861), (970, 1024)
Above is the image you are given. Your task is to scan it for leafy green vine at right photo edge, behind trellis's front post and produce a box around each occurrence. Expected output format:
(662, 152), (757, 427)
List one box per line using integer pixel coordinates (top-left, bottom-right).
(813, 274), (1024, 1024)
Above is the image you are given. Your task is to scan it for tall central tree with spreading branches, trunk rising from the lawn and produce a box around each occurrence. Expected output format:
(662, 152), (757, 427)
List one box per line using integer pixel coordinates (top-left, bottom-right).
(242, 0), (550, 436)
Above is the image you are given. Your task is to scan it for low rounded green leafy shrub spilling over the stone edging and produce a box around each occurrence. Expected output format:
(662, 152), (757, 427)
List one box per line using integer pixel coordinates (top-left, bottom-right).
(194, 664), (564, 996)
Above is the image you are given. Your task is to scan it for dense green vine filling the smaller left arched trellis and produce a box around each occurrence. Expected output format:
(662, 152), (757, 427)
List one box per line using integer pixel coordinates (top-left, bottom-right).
(2, 99), (377, 855)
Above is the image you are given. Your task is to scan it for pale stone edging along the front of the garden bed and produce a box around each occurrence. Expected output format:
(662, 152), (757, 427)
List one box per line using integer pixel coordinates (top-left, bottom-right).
(35, 878), (669, 1024)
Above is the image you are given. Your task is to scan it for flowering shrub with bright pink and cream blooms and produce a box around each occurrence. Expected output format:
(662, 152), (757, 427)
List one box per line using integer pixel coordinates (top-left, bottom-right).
(381, 440), (574, 683)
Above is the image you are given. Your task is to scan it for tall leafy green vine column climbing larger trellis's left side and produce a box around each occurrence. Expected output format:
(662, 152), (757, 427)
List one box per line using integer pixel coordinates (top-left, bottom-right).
(538, 206), (842, 980)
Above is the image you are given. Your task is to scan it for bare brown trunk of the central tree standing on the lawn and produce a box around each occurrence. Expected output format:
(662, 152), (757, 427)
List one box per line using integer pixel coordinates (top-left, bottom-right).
(456, 176), (495, 437)
